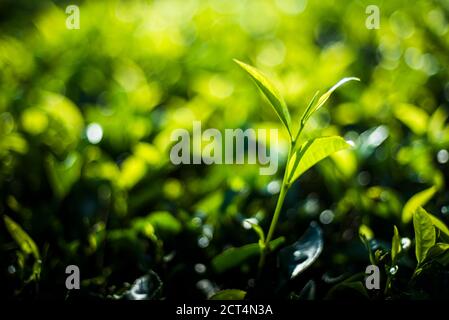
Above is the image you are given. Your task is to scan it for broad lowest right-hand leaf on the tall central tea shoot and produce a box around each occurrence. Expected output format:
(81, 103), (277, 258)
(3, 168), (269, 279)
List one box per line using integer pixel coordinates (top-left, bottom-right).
(287, 136), (350, 184)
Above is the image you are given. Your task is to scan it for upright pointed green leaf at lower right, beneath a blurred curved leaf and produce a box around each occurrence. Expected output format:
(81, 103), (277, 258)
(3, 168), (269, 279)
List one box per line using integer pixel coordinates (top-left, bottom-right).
(413, 207), (436, 265)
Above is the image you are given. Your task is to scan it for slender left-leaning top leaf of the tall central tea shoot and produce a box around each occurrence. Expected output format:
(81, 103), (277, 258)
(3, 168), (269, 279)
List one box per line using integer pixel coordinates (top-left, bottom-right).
(234, 59), (292, 137)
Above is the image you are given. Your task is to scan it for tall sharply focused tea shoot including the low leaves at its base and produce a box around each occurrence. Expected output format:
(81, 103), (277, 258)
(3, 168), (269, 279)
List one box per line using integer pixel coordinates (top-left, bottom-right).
(208, 60), (359, 298)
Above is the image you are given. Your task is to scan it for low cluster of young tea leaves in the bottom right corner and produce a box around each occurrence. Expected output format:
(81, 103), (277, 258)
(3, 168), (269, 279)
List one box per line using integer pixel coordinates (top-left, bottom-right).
(352, 206), (449, 299)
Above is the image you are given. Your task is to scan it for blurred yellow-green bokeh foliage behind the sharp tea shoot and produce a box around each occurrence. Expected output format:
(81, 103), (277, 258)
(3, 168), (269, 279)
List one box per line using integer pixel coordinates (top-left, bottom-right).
(0, 0), (449, 299)
